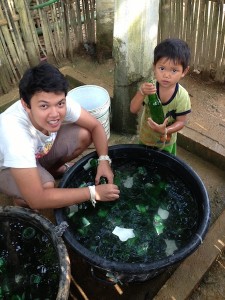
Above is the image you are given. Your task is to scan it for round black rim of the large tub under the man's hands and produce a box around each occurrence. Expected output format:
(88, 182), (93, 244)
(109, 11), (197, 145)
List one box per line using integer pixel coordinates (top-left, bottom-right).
(55, 144), (210, 274)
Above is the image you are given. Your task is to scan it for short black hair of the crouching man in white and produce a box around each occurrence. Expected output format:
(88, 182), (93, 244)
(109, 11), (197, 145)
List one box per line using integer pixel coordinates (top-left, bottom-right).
(19, 62), (68, 107)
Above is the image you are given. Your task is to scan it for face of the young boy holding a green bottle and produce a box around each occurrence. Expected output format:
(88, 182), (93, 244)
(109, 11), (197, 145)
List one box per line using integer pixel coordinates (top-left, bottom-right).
(154, 57), (189, 88)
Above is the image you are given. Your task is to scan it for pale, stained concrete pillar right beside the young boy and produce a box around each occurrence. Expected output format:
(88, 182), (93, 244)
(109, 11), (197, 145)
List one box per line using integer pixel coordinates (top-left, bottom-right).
(111, 0), (159, 134)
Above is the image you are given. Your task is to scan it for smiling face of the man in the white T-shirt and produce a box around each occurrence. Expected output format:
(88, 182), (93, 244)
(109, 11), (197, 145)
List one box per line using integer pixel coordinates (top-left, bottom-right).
(21, 92), (66, 135)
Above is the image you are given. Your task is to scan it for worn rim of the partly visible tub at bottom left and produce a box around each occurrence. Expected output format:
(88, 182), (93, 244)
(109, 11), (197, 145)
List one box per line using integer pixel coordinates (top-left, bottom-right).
(0, 205), (71, 300)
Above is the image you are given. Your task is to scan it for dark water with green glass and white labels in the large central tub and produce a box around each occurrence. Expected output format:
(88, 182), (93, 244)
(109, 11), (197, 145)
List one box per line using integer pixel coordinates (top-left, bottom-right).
(64, 158), (198, 263)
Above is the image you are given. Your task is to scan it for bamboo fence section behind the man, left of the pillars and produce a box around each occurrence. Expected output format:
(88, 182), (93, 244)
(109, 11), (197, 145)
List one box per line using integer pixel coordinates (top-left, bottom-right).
(0, 0), (95, 94)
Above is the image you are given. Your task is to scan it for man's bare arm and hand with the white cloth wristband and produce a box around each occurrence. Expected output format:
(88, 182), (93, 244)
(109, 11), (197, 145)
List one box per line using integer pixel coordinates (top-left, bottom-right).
(10, 168), (119, 209)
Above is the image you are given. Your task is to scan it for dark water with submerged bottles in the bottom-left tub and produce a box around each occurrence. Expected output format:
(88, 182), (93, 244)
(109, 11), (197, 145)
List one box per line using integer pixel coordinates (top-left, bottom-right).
(0, 217), (60, 300)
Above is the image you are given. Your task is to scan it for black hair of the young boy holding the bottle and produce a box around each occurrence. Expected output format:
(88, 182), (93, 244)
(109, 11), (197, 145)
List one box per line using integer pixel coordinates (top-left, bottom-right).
(154, 38), (191, 70)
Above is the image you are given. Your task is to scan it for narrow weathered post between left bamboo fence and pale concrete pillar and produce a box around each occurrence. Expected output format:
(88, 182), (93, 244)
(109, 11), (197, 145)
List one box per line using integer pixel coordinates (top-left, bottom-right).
(96, 0), (114, 63)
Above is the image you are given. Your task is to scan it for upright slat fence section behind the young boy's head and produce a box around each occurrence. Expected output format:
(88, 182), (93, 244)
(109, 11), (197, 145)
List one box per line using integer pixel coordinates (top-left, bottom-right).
(158, 0), (225, 83)
